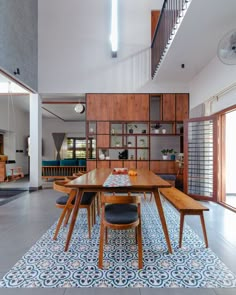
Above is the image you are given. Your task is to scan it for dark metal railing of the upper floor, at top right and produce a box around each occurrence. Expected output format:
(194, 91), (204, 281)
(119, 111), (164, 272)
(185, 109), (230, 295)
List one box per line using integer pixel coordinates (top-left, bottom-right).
(151, 0), (191, 78)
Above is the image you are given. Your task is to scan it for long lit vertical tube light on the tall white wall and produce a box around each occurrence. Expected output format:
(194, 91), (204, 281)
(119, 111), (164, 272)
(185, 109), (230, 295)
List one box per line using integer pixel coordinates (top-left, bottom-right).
(110, 0), (118, 57)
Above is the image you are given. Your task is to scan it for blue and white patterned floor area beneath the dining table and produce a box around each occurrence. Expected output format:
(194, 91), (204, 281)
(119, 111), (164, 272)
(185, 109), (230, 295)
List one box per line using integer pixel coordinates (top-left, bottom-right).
(0, 201), (236, 288)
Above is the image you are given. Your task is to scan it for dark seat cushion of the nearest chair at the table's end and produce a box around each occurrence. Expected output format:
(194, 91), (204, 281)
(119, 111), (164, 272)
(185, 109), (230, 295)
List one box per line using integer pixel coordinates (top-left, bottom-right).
(105, 204), (138, 224)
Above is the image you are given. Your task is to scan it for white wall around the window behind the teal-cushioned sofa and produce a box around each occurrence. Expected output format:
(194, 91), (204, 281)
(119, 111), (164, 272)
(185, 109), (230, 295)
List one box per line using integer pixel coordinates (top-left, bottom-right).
(42, 118), (85, 160)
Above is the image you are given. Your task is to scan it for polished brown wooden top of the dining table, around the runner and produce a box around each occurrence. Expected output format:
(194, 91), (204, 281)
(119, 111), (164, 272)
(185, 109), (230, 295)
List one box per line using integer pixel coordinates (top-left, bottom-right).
(65, 168), (171, 191)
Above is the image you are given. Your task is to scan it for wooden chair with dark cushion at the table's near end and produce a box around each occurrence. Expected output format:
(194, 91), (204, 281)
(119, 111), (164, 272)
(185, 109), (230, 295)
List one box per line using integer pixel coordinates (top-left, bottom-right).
(98, 194), (143, 269)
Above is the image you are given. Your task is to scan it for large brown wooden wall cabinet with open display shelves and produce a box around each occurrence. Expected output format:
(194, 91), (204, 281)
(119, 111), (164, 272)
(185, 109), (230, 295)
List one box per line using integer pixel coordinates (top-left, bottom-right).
(86, 93), (189, 174)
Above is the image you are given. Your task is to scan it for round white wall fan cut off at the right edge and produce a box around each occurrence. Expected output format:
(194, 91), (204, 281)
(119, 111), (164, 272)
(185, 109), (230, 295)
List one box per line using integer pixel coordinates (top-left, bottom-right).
(217, 29), (236, 65)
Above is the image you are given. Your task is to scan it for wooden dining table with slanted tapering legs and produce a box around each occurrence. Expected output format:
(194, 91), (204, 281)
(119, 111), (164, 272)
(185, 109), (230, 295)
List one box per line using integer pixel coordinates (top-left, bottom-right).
(64, 168), (172, 253)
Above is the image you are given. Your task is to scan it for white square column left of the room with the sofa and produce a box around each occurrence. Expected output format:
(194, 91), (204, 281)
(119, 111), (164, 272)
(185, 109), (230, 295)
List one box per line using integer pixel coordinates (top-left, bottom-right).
(30, 94), (42, 190)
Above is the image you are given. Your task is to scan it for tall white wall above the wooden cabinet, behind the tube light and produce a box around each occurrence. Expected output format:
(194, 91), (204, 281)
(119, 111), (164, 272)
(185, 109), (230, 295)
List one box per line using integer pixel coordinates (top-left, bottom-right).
(38, 0), (186, 93)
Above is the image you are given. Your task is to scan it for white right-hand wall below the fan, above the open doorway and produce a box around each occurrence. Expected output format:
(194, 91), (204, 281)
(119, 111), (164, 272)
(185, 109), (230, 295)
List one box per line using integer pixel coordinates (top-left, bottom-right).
(189, 57), (236, 112)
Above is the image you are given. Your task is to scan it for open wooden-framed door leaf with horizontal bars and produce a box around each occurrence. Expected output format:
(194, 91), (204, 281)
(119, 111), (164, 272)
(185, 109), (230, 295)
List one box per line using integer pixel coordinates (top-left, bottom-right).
(184, 119), (217, 200)
